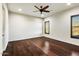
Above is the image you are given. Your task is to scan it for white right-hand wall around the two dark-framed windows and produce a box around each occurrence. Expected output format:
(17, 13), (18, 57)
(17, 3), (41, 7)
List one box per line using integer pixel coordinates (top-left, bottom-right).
(44, 7), (79, 45)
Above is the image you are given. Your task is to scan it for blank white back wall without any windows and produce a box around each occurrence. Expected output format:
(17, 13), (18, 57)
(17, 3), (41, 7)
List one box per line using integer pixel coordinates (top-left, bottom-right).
(9, 12), (42, 41)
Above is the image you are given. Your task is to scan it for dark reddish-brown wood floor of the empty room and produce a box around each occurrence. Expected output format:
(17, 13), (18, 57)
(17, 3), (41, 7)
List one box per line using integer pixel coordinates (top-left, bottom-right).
(3, 37), (79, 56)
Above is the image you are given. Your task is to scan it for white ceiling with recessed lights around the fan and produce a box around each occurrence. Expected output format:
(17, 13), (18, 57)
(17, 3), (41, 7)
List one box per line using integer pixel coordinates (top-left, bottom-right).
(8, 3), (79, 17)
